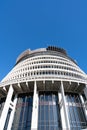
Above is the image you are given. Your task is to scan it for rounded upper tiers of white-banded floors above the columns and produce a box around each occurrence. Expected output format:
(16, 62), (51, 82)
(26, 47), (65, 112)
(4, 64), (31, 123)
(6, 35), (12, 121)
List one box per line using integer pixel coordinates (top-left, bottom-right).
(0, 46), (87, 86)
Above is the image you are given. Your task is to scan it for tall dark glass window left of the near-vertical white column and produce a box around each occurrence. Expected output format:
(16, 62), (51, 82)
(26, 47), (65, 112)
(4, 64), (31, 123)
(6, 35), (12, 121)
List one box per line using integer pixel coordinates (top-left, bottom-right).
(11, 94), (33, 130)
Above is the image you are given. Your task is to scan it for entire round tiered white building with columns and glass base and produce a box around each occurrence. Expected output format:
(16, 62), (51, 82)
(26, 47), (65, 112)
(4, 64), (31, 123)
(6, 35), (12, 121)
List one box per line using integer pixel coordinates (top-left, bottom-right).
(0, 46), (87, 130)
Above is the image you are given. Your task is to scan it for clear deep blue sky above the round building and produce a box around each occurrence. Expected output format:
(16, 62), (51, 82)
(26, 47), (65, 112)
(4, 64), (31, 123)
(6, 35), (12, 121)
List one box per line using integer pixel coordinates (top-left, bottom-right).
(0, 0), (87, 80)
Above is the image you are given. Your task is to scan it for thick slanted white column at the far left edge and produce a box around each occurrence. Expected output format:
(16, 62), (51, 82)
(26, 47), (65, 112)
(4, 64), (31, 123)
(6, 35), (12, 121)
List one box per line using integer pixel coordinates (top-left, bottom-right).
(0, 85), (13, 130)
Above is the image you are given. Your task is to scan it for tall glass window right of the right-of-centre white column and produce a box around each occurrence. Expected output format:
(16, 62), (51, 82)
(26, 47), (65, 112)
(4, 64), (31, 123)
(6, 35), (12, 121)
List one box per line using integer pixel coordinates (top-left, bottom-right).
(66, 93), (87, 130)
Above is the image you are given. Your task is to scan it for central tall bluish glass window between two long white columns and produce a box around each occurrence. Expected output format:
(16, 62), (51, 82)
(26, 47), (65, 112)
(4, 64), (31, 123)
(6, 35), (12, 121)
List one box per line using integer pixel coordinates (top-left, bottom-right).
(38, 93), (61, 130)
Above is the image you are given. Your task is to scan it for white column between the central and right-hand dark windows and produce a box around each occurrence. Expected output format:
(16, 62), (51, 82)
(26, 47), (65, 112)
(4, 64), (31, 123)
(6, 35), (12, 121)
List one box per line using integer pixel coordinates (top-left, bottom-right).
(59, 81), (70, 130)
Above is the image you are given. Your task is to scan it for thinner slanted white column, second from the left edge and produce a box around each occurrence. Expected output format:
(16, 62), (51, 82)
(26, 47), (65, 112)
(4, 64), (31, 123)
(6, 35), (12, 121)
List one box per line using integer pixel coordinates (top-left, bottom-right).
(7, 95), (17, 130)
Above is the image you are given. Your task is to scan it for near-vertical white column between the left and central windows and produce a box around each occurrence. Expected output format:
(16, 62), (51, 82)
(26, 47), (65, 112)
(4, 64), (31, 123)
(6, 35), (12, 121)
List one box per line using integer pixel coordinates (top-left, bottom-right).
(31, 81), (38, 130)
